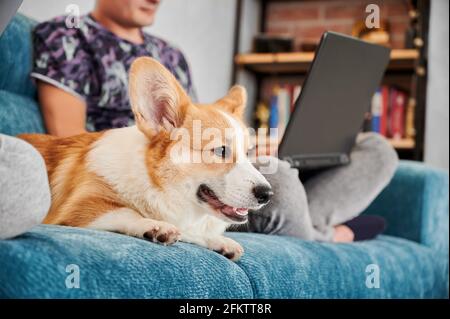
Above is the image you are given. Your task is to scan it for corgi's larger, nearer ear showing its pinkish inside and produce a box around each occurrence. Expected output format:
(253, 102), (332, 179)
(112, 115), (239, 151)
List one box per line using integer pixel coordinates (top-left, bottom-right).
(129, 57), (190, 137)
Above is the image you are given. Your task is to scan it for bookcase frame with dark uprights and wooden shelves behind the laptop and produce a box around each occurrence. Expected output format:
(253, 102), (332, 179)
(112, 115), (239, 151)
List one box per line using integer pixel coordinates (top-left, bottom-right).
(232, 0), (430, 161)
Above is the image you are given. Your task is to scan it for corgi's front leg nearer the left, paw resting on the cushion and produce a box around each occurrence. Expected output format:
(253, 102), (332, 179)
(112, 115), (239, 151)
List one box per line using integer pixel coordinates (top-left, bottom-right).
(87, 208), (180, 245)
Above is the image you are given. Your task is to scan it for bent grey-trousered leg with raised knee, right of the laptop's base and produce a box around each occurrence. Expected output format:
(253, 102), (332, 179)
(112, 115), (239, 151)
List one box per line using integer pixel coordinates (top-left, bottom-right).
(305, 133), (398, 237)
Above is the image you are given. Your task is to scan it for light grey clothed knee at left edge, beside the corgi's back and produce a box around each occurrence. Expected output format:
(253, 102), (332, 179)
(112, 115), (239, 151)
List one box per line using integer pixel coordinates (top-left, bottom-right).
(0, 134), (51, 239)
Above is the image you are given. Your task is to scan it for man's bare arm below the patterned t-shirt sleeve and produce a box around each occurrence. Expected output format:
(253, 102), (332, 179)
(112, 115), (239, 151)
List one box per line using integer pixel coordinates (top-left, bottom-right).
(37, 81), (86, 137)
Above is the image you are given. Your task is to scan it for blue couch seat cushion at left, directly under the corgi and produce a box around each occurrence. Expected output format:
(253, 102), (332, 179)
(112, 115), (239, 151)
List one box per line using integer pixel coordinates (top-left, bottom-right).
(0, 225), (252, 298)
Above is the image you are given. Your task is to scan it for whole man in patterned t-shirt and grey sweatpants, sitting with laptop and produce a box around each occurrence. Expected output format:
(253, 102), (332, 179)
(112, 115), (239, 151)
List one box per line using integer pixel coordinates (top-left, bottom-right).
(31, 0), (397, 242)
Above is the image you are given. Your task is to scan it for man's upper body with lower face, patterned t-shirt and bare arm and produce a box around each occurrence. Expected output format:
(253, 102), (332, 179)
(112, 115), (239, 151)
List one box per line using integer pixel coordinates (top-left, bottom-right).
(31, 0), (194, 136)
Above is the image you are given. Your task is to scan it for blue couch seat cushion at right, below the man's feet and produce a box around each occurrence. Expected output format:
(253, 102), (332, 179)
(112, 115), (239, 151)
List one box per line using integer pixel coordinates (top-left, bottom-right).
(227, 234), (446, 298)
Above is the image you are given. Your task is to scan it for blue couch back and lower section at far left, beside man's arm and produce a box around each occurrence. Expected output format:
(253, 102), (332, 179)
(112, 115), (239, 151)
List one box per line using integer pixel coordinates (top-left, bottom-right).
(0, 14), (45, 135)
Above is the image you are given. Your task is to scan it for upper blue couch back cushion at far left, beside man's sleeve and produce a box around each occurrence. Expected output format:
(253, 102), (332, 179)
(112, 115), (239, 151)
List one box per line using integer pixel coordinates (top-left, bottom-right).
(0, 14), (36, 97)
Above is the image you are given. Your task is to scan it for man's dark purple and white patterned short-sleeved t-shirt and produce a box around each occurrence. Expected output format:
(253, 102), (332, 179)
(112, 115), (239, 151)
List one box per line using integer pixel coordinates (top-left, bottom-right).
(31, 15), (195, 131)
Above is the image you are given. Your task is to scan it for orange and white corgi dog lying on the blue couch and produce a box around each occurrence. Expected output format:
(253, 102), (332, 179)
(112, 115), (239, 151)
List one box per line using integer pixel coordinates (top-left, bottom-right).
(19, 57), (273, 261)
